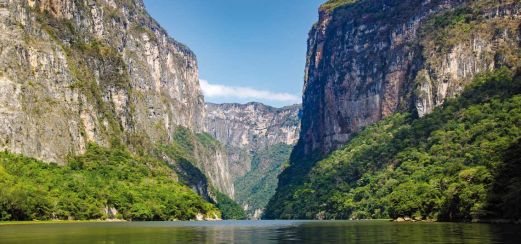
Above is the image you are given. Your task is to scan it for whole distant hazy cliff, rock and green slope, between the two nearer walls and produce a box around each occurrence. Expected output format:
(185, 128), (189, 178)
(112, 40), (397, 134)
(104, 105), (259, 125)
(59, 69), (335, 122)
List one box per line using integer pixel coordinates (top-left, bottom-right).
(206, 103), (300, 218)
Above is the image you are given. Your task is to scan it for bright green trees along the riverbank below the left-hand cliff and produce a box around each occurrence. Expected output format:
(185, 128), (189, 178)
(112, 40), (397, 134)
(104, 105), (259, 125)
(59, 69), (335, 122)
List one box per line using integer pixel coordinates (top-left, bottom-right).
(0, 145), (219, 220)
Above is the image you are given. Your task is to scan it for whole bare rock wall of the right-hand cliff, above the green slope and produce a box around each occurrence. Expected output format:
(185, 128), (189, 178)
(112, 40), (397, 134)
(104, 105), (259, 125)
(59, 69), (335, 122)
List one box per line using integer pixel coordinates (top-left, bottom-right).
(268, 0), (521, 218)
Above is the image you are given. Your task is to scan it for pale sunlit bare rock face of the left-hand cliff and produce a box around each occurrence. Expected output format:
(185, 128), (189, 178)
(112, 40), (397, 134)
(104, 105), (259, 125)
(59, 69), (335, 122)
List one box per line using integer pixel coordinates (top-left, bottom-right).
(0, 0), (204, 162)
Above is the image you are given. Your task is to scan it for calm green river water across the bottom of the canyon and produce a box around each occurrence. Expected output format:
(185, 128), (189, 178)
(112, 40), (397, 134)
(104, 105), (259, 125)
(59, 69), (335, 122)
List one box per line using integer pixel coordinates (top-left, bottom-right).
(0, 221), (521, 243)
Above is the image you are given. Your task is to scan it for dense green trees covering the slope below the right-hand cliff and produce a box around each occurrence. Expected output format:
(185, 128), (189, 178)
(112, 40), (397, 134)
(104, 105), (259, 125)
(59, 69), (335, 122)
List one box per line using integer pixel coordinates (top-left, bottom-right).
(267, 68), (521, 221)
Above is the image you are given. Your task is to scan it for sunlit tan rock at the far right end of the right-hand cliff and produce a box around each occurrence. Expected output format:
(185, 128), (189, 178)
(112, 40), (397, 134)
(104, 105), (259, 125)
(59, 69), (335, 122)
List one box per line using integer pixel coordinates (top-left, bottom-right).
(414, 1), (521, 116)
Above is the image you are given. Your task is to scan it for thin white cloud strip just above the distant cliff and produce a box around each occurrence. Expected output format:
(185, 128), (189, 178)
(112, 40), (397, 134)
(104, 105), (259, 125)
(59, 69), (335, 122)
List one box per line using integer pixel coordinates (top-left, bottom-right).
(199, 80), (301, 103)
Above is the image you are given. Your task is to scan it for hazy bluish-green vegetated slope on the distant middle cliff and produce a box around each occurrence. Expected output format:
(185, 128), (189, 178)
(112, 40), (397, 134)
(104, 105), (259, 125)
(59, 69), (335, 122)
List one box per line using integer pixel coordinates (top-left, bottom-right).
(234, 143), (292, 215)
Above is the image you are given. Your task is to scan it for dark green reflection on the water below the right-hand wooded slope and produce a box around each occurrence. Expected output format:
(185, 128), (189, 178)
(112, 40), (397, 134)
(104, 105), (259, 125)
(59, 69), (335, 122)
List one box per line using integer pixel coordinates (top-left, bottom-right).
(278, 221), (521, 243)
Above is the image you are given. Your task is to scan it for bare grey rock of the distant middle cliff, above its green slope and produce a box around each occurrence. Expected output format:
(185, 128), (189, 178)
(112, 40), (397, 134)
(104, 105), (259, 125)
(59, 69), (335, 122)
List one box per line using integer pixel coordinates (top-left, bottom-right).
(206, 103), (300, 178)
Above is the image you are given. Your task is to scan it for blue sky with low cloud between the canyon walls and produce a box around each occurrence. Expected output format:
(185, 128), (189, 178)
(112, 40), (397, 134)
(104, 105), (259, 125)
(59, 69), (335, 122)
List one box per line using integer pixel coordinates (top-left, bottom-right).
(144, 0), (325, 107)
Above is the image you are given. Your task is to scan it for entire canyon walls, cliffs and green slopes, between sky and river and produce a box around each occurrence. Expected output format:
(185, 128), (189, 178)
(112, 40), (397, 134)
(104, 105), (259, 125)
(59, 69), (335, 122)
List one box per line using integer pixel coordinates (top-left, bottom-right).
(0, 0), (521, 221)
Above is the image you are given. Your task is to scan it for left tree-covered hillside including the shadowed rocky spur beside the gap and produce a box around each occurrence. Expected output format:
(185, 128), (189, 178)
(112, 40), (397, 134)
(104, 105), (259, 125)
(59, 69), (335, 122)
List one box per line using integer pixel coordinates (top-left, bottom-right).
(0, 127), (245, 221)
